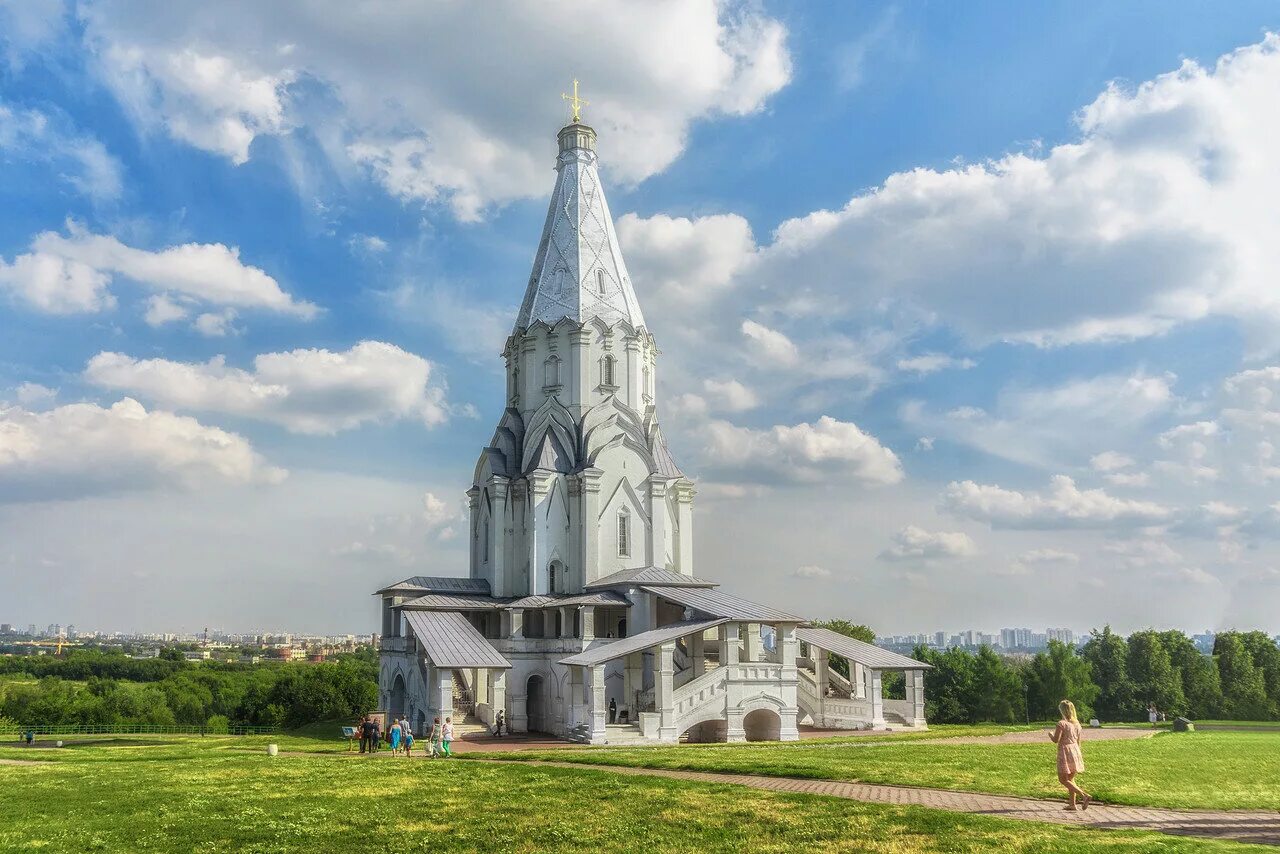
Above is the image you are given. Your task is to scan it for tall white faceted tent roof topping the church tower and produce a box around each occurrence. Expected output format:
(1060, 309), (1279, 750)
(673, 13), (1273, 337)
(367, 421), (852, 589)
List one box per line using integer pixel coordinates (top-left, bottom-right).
(516, 122), (644, 332)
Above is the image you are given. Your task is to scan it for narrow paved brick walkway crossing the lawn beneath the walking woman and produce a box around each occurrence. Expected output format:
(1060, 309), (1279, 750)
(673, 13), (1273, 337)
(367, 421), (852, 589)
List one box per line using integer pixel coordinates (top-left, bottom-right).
(521, 762), (1280, 845)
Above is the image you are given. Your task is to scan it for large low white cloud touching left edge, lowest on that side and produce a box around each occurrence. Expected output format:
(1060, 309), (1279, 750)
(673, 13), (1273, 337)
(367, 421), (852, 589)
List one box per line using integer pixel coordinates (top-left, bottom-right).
(0, 398), (285, 502)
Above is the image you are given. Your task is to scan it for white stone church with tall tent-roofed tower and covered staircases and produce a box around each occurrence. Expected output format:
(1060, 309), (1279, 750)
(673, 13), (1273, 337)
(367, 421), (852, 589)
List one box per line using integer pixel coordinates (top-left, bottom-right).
(378, 120), (928, 744)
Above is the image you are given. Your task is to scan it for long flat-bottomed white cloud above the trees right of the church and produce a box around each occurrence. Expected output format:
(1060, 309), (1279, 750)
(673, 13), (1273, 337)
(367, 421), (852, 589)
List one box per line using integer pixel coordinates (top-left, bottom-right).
(940, 475), (1174, 529)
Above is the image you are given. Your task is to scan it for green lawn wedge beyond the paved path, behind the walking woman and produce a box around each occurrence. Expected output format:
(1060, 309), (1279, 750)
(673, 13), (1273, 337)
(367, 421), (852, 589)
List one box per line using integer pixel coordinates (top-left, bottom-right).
(475, 732), (1280, 809)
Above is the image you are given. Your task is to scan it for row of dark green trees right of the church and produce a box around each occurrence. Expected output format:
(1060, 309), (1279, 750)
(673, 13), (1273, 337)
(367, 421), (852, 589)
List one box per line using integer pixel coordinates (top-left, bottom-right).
(911, 626), (1280, 723)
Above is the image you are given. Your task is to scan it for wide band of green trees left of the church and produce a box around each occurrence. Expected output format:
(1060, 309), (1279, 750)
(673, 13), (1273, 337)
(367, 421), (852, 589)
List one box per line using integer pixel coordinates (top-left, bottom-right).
(0, 650), (378, 731)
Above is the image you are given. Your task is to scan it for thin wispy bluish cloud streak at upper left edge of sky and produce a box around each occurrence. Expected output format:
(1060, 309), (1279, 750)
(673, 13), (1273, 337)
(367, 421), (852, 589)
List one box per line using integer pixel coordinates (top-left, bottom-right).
(0, 102), (124, 202)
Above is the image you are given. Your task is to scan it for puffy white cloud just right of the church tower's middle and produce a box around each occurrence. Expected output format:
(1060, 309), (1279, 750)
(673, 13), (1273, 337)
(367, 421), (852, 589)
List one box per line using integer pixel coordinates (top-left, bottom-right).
(704, 415), (902, 484)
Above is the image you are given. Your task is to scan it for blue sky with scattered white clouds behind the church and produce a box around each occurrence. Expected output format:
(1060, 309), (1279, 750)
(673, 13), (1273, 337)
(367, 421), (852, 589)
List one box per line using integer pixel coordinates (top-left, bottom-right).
(0, 1), (1280, 631)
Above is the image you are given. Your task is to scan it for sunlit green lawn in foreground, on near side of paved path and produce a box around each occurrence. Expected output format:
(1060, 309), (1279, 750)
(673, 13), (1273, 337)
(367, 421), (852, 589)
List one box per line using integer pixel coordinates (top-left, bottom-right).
(0, 736), (1271, 854)
